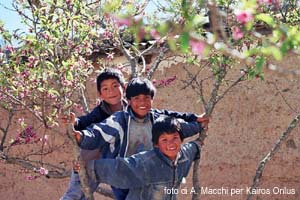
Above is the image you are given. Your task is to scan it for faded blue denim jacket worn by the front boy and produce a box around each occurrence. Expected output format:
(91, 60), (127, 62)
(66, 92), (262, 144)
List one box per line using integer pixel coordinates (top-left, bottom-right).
(94, 142), (200, 200)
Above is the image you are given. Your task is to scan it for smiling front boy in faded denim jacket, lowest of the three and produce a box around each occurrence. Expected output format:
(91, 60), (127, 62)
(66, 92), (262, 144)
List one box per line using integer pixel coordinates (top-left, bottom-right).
(88, 116), (200, 200)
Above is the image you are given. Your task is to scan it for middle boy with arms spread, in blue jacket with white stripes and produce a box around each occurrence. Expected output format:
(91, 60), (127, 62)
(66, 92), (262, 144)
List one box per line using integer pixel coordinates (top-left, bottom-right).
(74, 78), (208, 199)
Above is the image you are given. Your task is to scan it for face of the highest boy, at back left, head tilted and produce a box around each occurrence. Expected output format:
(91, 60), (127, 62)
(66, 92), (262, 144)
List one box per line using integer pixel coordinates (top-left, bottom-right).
(99, 79), (123, 105)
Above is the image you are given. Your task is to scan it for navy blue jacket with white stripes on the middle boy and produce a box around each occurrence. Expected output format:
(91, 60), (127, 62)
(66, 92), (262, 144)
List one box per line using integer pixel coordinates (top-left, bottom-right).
(79, 106), (202, 158)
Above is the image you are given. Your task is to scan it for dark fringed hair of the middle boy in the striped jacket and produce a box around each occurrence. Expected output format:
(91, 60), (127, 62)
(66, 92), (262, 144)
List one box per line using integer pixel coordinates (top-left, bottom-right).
(125, 78), (156, 100)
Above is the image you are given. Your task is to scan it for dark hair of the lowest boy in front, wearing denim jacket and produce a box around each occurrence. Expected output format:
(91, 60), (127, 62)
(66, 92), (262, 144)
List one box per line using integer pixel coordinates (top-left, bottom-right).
(152, 115), (183, 144)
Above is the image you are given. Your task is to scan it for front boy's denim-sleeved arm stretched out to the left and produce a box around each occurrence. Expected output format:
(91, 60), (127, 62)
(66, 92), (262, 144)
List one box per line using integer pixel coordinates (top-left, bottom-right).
(94, 157), (145, 189)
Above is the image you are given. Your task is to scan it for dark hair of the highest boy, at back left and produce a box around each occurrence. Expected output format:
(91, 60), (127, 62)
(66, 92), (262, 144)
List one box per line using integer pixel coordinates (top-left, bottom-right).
(97, 68), (125, 92)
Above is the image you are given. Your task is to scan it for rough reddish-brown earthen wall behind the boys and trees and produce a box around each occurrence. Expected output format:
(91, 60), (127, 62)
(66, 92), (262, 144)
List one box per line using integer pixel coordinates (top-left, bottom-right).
(0, 55), (300, 200)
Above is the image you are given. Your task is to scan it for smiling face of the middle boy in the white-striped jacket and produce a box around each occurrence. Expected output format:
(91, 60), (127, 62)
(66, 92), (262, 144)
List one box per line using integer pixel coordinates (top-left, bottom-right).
(128, 94), (152, 118)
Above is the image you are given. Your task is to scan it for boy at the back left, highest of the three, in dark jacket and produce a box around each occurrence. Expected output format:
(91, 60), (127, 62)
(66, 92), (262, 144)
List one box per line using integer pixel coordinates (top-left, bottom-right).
(61, 68), (127, 200)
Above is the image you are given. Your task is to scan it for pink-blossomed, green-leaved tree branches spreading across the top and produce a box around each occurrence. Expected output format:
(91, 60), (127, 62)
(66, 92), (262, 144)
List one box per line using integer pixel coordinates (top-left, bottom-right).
(0, 0), (300, 199)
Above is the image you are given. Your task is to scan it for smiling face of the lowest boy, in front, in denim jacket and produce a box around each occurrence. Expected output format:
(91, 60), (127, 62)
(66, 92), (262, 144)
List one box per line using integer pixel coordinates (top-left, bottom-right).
(154, 132), (182, 161)
